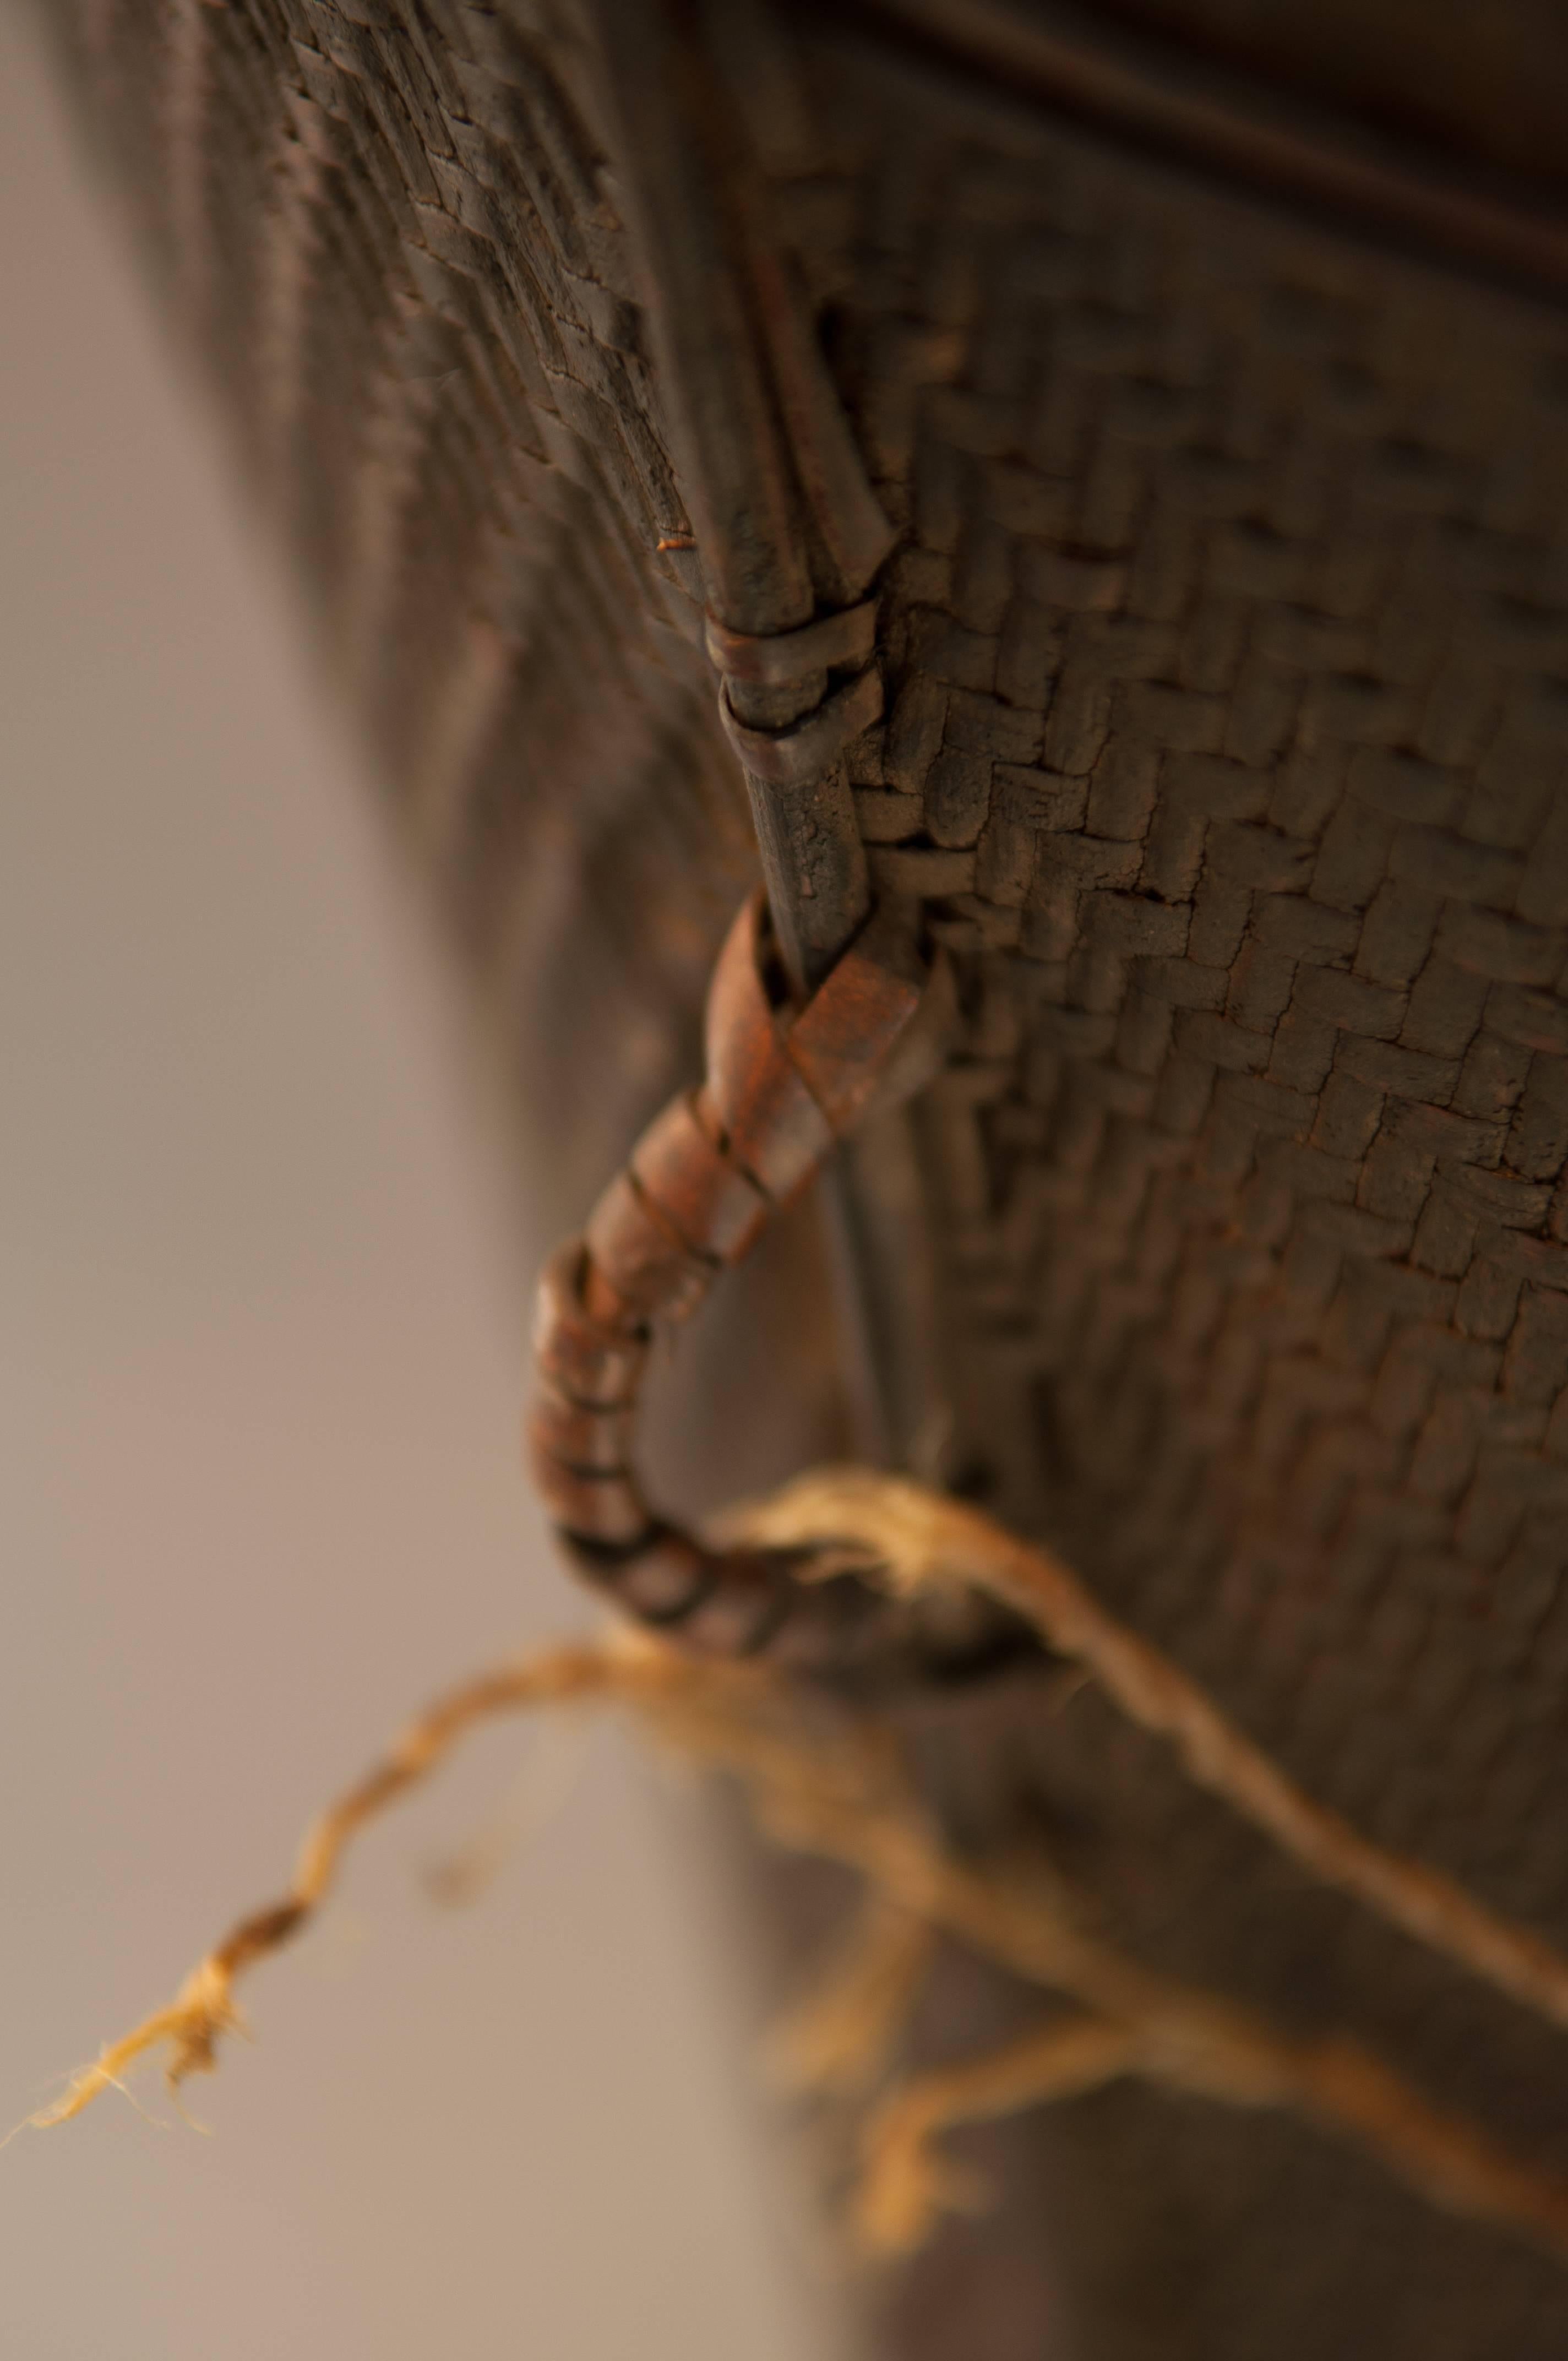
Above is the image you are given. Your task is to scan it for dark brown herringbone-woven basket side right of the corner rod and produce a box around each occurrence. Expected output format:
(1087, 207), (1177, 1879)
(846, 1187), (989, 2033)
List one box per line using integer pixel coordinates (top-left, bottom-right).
(798, 47), (1568, 2361)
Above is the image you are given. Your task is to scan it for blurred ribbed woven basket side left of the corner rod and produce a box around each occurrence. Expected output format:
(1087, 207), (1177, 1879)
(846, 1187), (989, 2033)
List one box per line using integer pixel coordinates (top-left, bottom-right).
(50, 0), (753, 1221)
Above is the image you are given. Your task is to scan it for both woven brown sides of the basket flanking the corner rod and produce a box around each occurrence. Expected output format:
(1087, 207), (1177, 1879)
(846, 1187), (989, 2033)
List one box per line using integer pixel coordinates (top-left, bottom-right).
(46, 0), (1568, 2361)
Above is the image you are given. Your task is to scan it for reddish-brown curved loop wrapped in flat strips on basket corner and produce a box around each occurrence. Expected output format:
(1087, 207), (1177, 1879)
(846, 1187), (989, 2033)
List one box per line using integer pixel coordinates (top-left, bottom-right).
(529, 895), (925, 1664)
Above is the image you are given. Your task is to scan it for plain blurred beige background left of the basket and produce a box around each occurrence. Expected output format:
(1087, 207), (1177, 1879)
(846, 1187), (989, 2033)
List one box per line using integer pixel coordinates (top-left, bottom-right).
(0, 23), (834, 2361)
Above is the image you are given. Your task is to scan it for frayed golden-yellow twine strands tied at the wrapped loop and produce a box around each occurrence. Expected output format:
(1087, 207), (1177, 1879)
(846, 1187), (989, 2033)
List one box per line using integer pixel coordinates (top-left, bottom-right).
(31, 1476), (1568, 2260)
